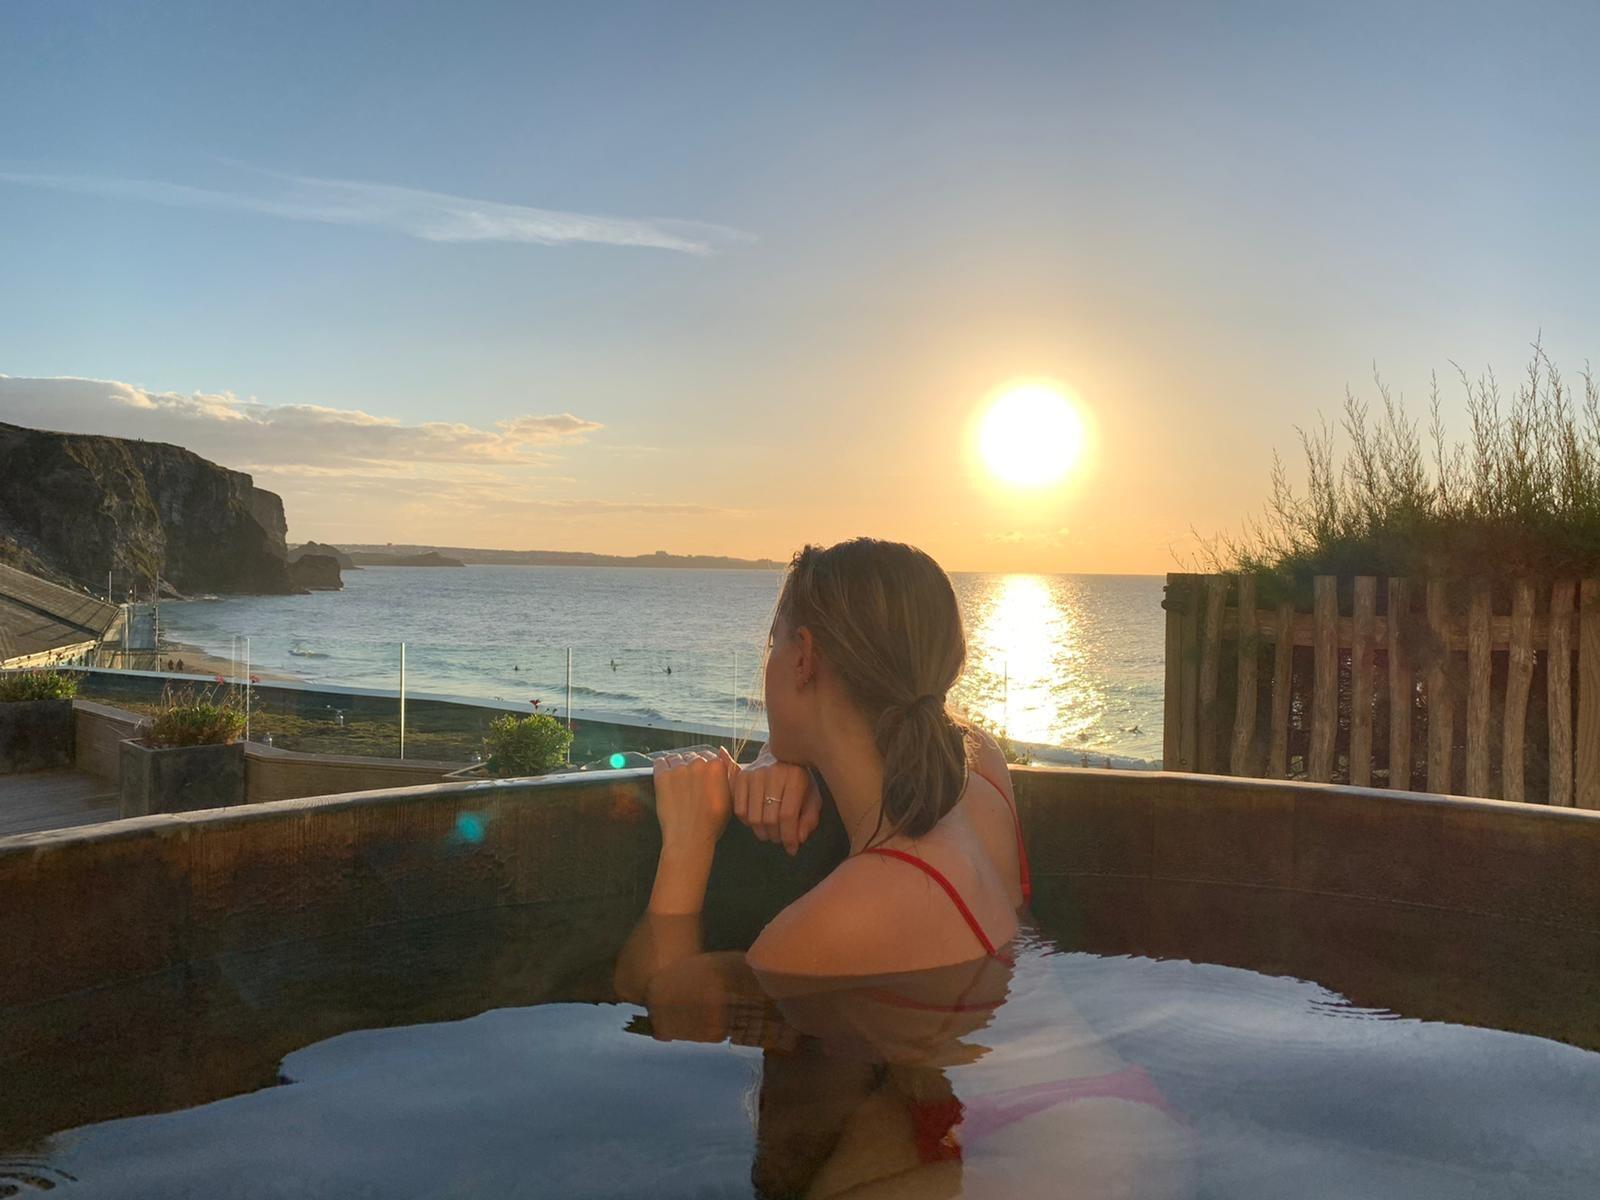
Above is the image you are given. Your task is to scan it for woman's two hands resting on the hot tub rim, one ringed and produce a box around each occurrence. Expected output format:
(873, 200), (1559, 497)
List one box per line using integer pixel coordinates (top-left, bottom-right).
(654, 747), (822, 854)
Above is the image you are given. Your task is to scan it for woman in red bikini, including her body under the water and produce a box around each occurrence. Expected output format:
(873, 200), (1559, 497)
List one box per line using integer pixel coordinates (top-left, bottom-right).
(618, 538), (1184, 1197)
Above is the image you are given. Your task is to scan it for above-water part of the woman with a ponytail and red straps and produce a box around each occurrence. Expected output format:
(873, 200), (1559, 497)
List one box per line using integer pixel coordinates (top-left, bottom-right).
(627, 538), (1027, 976)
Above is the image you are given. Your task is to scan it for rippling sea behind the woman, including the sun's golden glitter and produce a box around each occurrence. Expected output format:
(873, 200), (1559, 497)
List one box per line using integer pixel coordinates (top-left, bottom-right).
(160, 565), (1165, 766)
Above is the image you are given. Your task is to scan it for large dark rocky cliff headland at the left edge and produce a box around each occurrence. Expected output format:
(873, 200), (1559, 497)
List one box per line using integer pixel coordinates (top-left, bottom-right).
(0, 422), (299, 595)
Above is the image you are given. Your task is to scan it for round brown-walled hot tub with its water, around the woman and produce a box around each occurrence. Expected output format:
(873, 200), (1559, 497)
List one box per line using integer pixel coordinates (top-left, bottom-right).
(0, 768), (1600, 1200)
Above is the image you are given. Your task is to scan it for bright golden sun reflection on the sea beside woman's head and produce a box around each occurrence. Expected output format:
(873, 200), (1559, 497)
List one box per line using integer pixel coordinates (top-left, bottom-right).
(955, 574), (1106, 746)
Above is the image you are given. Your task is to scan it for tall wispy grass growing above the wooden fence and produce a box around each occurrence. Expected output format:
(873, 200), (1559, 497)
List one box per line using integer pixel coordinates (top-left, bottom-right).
(1202, 342), (1600, 581)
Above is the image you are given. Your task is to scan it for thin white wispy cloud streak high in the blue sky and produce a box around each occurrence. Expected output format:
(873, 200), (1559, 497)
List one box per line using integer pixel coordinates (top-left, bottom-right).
(0, 168), (754, 254)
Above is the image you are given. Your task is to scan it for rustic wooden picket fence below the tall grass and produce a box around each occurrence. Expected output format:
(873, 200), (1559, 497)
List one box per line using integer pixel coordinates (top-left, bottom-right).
(1163, 574), (1600, 808)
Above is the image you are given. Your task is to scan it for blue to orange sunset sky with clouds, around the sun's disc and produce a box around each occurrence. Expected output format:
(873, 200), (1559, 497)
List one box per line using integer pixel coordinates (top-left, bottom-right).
(0, 0), (1600, 573)
